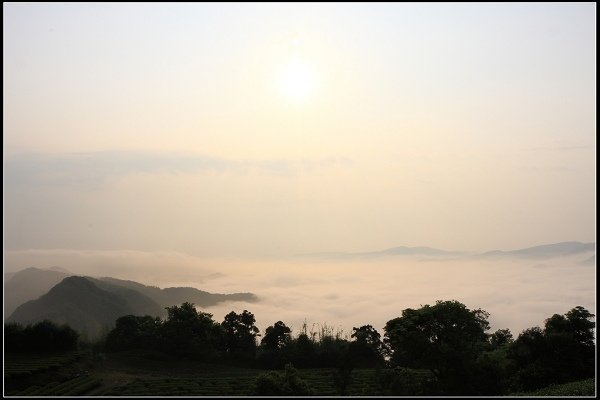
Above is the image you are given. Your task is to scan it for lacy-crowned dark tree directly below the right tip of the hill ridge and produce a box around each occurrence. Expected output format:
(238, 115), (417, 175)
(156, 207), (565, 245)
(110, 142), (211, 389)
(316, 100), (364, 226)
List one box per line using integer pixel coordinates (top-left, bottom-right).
(221, 310), (260, 354)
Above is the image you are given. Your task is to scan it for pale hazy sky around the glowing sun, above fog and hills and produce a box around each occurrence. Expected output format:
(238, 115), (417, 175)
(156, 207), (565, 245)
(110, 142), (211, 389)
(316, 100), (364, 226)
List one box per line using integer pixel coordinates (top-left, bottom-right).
(3, 3), (596, 256)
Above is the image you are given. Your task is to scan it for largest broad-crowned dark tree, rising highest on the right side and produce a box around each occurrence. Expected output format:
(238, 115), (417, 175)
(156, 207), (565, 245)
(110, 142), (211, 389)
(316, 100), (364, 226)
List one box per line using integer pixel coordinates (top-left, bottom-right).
(384, 300), (489, 395)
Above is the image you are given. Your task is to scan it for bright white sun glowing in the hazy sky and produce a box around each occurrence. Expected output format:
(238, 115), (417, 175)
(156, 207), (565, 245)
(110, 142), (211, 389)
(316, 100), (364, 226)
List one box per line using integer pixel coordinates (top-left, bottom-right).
(279, 59), (316, 101)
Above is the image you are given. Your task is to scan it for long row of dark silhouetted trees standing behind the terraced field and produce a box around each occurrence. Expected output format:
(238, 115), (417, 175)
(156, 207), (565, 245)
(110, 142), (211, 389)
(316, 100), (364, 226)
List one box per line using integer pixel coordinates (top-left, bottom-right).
(5, 301), (595, 396)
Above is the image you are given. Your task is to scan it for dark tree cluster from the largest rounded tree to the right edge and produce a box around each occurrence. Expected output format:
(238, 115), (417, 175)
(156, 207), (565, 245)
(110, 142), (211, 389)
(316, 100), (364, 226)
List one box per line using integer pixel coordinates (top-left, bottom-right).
(384, 301), (595, 395)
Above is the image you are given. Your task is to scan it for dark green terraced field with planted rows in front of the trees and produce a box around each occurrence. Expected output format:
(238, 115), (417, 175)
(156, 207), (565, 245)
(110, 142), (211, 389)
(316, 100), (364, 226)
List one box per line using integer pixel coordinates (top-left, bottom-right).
(4, 352), (596, 397)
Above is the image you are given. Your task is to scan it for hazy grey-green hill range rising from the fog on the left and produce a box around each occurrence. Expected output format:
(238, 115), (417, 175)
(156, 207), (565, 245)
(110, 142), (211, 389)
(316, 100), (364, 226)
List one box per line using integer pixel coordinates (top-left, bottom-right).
(5, 274), (257, 337)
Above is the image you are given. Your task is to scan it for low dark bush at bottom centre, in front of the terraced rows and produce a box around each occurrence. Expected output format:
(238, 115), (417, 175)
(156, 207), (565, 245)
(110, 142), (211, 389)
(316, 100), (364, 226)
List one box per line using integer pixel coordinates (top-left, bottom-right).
(254, 364), (313, 396)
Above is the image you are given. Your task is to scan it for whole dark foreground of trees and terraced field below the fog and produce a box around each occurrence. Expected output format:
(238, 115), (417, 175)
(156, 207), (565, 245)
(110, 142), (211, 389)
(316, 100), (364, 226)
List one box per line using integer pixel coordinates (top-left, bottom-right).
(4, 301), (595, 396)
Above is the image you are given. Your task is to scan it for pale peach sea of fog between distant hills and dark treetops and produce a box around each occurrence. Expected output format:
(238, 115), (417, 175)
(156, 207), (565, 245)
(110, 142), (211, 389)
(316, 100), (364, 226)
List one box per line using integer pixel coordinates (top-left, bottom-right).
(5, 250), (596, 337)
